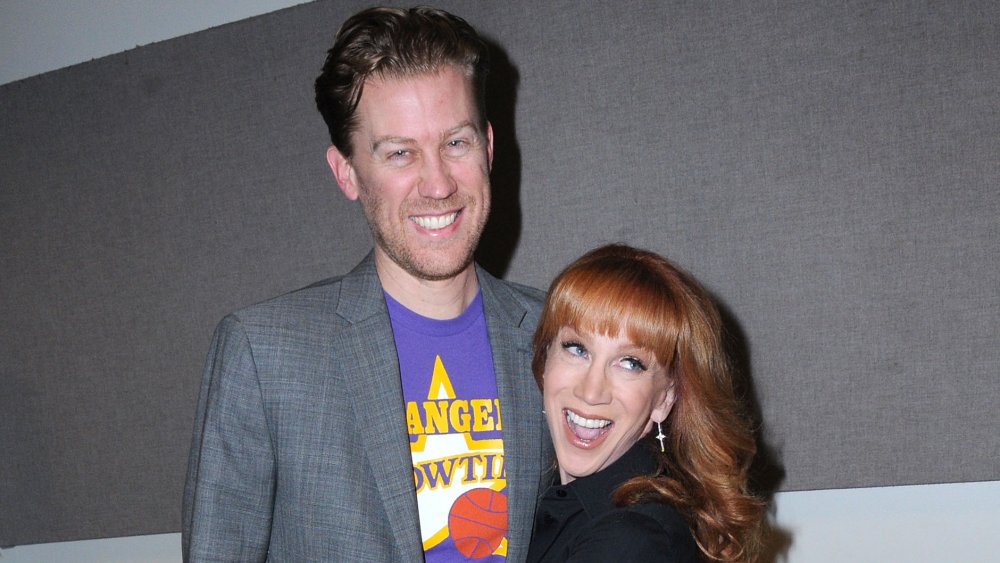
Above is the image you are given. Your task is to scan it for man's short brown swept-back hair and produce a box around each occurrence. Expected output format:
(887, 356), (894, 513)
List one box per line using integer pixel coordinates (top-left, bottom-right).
(316, 6), (489, 157)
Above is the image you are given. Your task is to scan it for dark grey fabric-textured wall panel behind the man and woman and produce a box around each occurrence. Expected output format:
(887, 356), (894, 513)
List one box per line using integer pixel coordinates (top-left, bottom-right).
(0, 1), (1000, 545)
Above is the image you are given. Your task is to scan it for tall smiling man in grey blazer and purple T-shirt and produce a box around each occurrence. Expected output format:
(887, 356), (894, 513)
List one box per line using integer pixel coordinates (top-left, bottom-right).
(183, 8), (551, 562)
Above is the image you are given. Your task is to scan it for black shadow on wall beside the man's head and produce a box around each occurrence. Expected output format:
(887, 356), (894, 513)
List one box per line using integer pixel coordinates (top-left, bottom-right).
(476, 39), (521, 278)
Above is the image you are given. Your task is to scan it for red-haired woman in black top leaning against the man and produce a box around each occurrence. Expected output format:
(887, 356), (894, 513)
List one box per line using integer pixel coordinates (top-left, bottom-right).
(528, 245), (764, 562)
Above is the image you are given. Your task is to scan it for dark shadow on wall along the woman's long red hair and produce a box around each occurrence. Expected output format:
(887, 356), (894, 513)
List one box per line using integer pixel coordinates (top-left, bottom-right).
(712, 295), (792, 563)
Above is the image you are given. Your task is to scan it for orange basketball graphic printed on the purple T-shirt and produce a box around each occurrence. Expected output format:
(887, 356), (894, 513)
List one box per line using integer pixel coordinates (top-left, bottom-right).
(448, 488), (507, 559)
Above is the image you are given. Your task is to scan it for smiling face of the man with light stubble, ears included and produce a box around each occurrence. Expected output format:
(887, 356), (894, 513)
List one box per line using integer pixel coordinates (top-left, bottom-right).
(327, 66), (493, 280)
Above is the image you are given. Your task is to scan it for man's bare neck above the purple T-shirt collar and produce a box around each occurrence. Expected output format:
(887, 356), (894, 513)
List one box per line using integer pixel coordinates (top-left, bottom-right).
(375, 252), (479, 319)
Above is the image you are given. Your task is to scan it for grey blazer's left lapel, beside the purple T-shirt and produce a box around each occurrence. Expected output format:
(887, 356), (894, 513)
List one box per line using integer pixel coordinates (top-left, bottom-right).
(335, 254), (423, 561)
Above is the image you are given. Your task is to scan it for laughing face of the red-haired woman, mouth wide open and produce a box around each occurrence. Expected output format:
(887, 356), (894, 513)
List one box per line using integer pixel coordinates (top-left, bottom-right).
(542, 327), (674, 484)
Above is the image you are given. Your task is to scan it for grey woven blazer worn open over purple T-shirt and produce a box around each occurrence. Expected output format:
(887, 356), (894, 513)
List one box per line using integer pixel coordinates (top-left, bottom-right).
(182, 254), (553, 563)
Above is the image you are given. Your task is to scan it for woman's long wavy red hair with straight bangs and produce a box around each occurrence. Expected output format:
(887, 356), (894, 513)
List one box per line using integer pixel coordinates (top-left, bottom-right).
(532, 245), (764, 561)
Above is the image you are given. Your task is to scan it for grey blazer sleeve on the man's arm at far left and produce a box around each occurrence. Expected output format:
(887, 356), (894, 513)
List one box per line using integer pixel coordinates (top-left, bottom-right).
(181, 316), (275, 561)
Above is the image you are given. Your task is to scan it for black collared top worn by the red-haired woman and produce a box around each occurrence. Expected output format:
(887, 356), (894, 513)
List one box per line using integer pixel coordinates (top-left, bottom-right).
(528, 442), (699, 563)
